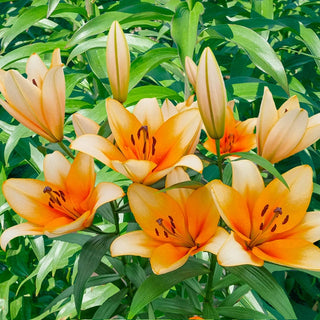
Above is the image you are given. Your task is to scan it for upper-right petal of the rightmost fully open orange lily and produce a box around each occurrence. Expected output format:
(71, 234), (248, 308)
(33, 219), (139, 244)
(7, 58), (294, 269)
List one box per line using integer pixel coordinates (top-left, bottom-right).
(252, 165), (313, 238)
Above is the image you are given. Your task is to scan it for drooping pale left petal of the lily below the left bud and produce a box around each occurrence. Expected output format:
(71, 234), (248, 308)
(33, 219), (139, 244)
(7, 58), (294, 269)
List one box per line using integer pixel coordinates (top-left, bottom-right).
(70, 134), (125, 167)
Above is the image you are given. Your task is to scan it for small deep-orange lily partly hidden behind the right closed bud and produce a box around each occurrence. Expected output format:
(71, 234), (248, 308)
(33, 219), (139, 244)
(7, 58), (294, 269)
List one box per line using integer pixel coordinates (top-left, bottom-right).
(203, 101), (257, 154)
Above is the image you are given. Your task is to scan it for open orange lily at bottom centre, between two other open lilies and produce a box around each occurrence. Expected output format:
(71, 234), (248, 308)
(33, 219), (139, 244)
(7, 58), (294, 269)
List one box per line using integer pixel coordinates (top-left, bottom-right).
(110, 168), (228, 274)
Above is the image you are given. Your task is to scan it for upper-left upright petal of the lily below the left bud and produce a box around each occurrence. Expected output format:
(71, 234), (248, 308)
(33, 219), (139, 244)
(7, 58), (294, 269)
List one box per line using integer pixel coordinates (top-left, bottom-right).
(106, 98), (141, 158)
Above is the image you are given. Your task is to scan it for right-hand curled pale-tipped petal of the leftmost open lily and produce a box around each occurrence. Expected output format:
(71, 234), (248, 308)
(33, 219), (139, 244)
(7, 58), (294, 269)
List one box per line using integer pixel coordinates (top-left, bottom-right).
(89, 182), (125, 212)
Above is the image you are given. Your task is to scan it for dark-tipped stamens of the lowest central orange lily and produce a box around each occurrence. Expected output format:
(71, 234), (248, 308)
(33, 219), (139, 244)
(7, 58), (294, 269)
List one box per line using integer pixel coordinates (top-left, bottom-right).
(154, 216), (200, 248)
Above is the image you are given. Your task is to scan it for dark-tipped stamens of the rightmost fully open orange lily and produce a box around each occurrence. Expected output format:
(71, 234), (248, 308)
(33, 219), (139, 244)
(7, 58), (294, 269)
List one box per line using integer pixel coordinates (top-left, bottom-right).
(247, 204), (289, 249)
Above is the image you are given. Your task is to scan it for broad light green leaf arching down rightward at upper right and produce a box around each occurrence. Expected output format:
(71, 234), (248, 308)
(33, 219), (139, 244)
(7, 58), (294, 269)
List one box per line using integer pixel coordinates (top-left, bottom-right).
(205, 24), (289, 93)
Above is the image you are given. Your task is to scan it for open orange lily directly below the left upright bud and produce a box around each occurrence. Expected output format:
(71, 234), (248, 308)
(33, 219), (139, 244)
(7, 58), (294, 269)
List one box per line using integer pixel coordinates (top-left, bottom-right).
(71, 99), (202, 184)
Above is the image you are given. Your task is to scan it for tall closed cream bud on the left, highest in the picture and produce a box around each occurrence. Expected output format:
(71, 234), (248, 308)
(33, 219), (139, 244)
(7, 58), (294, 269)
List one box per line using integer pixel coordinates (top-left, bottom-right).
(107, 21), (130, 102)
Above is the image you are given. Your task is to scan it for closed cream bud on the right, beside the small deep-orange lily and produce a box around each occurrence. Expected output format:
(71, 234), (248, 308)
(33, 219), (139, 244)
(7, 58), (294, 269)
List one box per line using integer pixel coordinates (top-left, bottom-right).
(196, 48), (227, 139)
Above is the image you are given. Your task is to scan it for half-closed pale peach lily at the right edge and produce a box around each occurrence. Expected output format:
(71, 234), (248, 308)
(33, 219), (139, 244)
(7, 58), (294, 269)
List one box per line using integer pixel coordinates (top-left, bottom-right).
(257, 88), (320, 163)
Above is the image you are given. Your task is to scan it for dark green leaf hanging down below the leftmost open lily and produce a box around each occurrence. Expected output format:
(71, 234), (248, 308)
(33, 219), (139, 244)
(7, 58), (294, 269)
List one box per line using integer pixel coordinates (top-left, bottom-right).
(74, 234), (114, 313)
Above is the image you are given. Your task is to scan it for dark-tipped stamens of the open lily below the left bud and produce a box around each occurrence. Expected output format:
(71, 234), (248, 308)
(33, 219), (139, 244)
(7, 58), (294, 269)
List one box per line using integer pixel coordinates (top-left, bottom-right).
(130, 126), (157, 160)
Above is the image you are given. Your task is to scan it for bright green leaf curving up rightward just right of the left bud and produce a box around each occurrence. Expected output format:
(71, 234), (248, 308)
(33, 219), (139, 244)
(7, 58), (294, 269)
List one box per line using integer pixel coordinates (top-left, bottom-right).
(129, 48), (177, 90)
